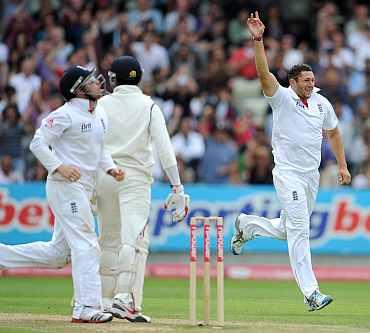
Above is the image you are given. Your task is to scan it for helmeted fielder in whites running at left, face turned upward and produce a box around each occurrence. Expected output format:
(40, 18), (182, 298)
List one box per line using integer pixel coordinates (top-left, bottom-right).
(0, 66), (124, 323)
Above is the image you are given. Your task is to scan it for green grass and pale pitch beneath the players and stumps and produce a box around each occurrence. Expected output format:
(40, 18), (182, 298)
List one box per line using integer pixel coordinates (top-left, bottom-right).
(0, 277), (370, 333)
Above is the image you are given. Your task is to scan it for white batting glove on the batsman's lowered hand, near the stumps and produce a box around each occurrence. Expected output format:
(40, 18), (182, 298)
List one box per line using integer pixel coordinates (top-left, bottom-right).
(164, 185), (190, 223)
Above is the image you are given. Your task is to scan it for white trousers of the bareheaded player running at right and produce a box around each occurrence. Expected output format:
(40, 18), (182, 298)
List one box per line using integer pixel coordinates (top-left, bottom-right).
(243, 168), (319, 297)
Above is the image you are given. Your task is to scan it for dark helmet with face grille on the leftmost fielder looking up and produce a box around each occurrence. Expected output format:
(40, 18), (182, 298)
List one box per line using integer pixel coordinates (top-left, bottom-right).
(59, 66), (95, 101)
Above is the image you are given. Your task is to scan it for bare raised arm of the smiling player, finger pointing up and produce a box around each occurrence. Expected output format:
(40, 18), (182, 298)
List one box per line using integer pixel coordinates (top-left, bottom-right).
(247, 11), (279, 96)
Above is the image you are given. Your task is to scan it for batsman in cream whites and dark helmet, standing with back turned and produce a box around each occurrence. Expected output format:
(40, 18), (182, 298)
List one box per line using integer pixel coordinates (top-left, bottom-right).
(97, 56), (189, 322)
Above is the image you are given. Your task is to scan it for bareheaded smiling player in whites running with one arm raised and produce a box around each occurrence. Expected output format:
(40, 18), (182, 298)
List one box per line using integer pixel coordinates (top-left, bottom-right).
(231, 12), (351, 311)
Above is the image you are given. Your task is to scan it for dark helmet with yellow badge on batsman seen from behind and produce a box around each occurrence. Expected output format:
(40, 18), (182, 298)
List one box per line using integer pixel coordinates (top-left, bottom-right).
(108, 56), (143, 87)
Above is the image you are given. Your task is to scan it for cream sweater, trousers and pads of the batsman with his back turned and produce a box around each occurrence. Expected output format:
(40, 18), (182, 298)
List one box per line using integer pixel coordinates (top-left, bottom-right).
(97, 85), (177, 310)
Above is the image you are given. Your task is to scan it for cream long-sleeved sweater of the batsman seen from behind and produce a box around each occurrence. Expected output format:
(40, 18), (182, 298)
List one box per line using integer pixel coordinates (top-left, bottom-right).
(98, 85), (177, 182)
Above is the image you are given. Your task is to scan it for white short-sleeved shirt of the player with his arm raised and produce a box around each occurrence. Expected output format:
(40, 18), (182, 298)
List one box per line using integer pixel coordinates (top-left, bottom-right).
(265, 86), (338, 173)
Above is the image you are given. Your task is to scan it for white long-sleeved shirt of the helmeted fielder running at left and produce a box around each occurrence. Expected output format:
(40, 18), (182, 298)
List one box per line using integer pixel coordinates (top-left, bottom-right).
(30, 98), (115, 184)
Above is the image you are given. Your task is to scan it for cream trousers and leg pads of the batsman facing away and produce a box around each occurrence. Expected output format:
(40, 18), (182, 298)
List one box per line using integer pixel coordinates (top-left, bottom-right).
(97, 172), (151, 311)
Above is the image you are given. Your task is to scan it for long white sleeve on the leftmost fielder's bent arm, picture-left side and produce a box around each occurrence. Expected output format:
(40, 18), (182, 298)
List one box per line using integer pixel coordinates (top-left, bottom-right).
(30, 110), (72, 173)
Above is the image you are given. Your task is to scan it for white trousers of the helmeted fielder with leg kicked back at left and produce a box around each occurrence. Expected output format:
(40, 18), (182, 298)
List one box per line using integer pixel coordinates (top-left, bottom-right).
(0, 180), (102, 318)
